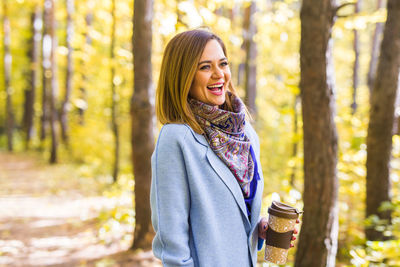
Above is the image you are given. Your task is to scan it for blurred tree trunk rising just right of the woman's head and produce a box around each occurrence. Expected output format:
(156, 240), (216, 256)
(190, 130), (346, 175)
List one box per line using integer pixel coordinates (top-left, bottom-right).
(243, 1), (257, 115)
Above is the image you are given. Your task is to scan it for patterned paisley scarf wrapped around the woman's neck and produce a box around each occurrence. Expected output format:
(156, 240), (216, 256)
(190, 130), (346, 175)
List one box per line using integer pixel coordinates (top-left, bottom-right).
(189, 93), (254, 198)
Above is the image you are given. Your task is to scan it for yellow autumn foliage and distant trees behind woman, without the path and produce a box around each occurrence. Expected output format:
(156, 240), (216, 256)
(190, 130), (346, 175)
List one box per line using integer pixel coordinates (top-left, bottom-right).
(0, 0), (400, 266)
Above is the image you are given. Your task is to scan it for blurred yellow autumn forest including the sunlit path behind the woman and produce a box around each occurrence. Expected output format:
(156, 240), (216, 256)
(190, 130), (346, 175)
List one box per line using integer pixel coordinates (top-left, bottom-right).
(0, 0), (400, 266)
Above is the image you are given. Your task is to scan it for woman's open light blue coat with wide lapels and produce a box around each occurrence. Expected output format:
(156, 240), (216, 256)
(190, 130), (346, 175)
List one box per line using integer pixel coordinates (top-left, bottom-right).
(150, 123), (264, 267)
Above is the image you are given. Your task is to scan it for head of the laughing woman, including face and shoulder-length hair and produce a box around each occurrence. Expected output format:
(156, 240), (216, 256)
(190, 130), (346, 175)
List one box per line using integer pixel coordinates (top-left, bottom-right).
(156, 30), (239, 133)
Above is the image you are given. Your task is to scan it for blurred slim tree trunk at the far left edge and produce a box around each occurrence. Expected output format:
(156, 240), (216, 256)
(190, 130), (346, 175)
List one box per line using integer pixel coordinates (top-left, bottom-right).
(3, 0), (14, 151)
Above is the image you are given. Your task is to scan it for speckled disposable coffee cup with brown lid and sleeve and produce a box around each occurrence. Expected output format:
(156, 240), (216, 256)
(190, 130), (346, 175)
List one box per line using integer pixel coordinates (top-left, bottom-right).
(265, 201), (302, 264)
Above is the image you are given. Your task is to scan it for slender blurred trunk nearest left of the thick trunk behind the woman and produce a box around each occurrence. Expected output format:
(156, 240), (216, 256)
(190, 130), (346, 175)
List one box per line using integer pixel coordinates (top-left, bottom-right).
(110, 0), (120, 183)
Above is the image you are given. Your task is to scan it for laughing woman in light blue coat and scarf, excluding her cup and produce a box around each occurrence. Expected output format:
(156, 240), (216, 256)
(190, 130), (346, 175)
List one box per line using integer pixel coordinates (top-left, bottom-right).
(151, 30), (296, 267)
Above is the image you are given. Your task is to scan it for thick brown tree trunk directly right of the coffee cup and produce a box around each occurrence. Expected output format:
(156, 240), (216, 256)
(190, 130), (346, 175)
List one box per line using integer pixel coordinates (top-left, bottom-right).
(295, 0), (338, 267)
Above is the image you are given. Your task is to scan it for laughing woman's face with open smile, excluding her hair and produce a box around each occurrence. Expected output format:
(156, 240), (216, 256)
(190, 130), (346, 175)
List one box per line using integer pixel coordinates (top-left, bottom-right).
(189, 39), (231, 106)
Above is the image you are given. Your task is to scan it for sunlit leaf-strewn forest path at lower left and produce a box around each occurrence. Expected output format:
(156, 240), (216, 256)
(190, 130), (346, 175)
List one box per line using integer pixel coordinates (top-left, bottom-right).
(0, 152), (161, 267)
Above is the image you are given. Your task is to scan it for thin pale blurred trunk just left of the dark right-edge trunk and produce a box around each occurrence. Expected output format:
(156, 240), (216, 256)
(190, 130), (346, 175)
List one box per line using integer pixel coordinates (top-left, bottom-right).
(367, 0), (384, 94)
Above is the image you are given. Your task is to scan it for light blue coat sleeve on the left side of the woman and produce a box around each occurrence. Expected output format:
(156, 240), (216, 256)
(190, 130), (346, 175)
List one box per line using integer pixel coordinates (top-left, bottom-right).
(150, 126), (194, 267)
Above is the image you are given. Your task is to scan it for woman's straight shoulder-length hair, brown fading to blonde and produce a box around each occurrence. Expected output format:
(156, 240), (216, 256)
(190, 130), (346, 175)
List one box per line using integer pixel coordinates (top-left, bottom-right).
(156, 29), (244, 134)
